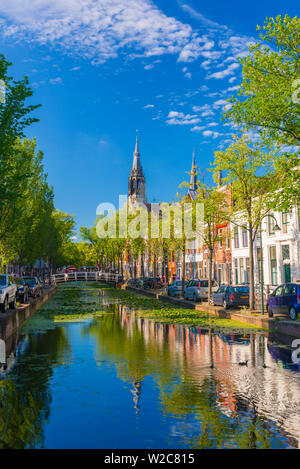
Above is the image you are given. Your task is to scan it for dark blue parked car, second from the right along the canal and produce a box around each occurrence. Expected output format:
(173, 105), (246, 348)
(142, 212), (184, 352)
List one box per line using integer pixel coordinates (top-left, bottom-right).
(210, 285), (249, 309)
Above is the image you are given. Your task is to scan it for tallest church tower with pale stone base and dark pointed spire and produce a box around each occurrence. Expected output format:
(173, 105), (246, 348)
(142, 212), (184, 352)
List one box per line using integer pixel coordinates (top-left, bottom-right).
(128, 136), (148, 206)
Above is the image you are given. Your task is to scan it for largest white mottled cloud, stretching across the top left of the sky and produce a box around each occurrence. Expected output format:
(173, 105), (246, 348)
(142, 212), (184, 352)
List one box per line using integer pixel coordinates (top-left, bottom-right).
(0, 0), (222, 67)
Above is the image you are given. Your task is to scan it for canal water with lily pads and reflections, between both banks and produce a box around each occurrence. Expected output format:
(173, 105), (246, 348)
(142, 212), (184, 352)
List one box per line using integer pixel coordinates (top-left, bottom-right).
(0, 283), (300, 449)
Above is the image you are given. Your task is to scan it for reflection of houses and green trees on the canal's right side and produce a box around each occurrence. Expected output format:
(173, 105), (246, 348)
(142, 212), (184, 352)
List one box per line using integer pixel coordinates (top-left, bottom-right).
(83, 306), (300, 448)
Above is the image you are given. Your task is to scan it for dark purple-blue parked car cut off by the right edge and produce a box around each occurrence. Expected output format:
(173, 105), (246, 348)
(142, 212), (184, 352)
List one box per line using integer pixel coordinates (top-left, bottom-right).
(267, 283), (300, 320)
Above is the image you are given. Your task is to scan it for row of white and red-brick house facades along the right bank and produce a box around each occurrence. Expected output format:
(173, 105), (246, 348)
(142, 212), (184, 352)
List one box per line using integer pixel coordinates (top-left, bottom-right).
(178, 207), (300, 287)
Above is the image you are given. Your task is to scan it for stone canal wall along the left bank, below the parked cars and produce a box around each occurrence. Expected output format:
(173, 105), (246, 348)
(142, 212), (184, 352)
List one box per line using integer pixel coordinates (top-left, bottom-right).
(0, 286), (57, 340)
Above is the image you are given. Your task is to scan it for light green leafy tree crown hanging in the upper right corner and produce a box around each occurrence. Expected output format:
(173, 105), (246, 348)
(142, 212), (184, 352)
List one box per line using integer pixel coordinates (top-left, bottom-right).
(225, 15), (300, 146)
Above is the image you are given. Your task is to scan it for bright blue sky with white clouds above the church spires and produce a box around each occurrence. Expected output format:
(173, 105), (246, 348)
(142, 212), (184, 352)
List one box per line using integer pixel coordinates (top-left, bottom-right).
(0, 0), (299, 232)
